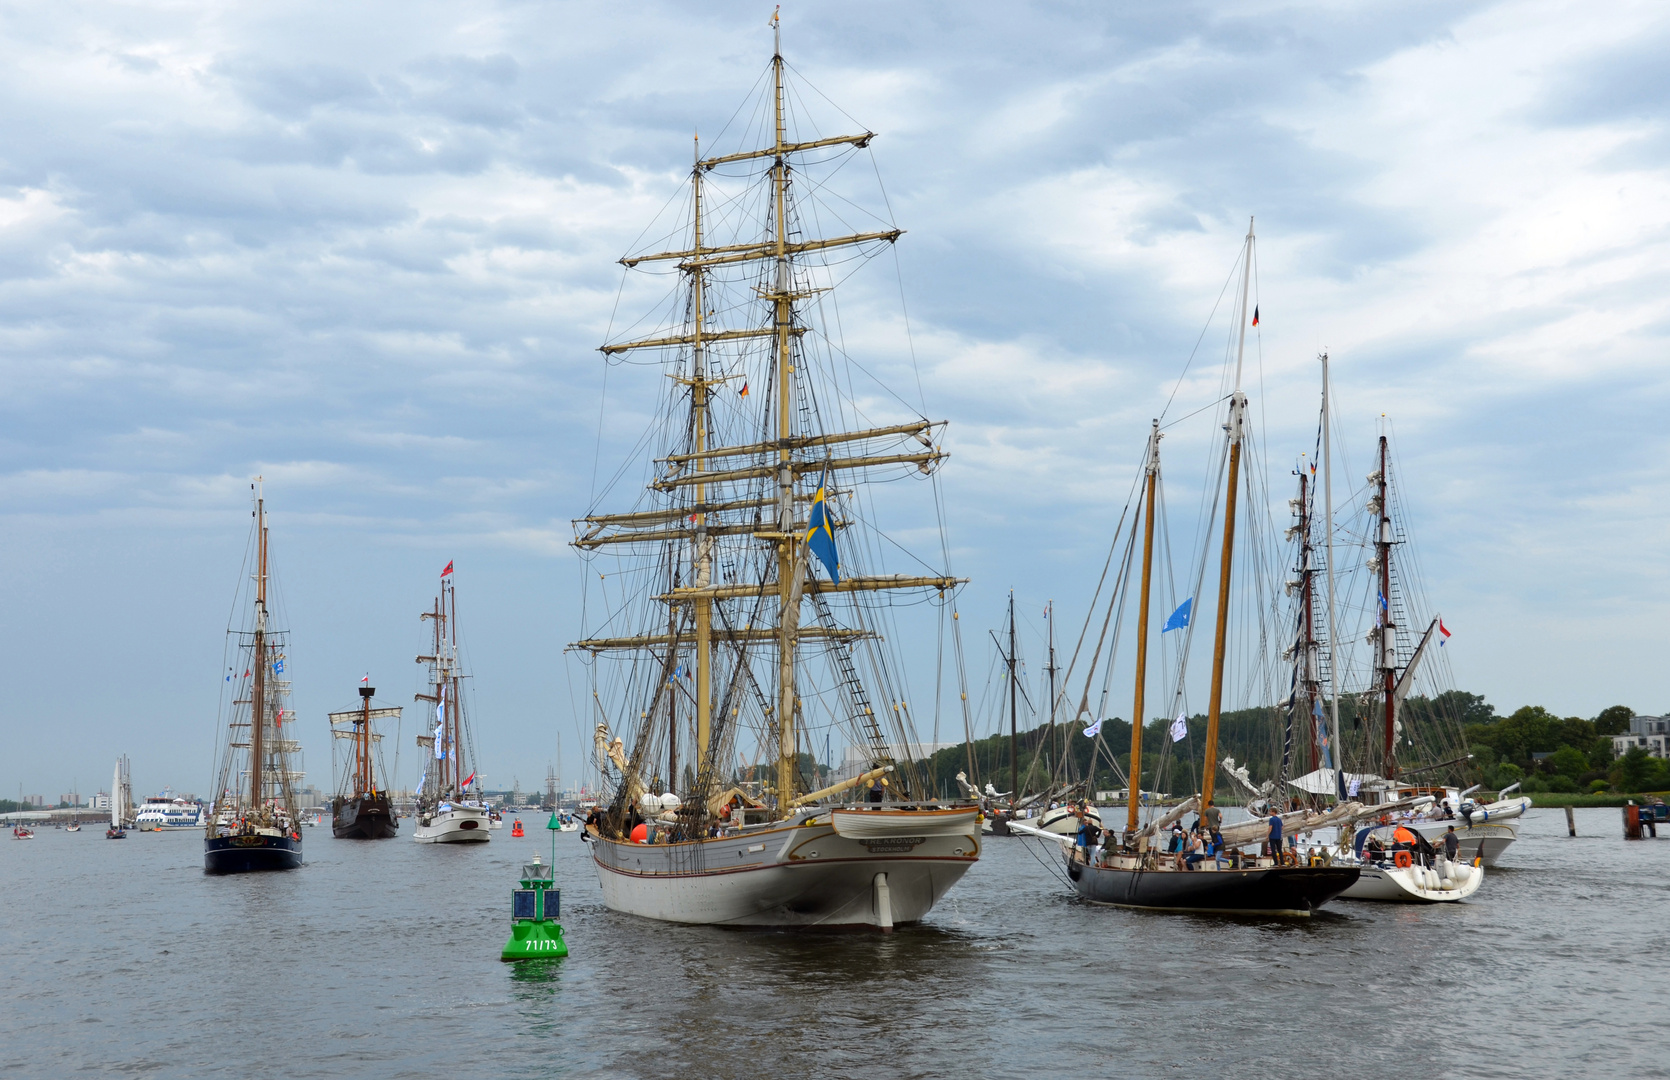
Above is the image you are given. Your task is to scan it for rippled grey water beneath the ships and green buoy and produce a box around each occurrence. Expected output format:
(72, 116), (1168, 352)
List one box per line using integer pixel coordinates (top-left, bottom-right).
(0, 810), (1670, 1080)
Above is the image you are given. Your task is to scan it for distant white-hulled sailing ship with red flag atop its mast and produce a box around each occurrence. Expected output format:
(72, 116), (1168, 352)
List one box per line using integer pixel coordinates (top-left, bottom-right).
(412, 563), (491, 843)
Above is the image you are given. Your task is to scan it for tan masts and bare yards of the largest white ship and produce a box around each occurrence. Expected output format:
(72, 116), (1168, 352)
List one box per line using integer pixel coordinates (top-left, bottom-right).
(574, 17), (962, 811)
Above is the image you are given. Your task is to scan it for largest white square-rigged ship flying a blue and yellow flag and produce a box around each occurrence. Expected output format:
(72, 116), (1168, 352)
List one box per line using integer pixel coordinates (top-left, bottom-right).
(573, 18), (980, 928)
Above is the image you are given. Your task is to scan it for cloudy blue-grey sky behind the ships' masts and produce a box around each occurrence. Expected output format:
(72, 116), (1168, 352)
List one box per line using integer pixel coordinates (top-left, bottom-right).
(0, 0), (1670, 798)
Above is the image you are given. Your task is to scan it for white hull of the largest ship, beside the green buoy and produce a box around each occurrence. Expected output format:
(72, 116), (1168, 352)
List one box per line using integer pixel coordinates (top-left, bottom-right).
(590, 810), (980, 926)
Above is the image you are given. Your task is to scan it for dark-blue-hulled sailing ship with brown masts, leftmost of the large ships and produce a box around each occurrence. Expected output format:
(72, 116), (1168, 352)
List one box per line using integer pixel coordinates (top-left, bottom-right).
(204, 477), (302, 873)
